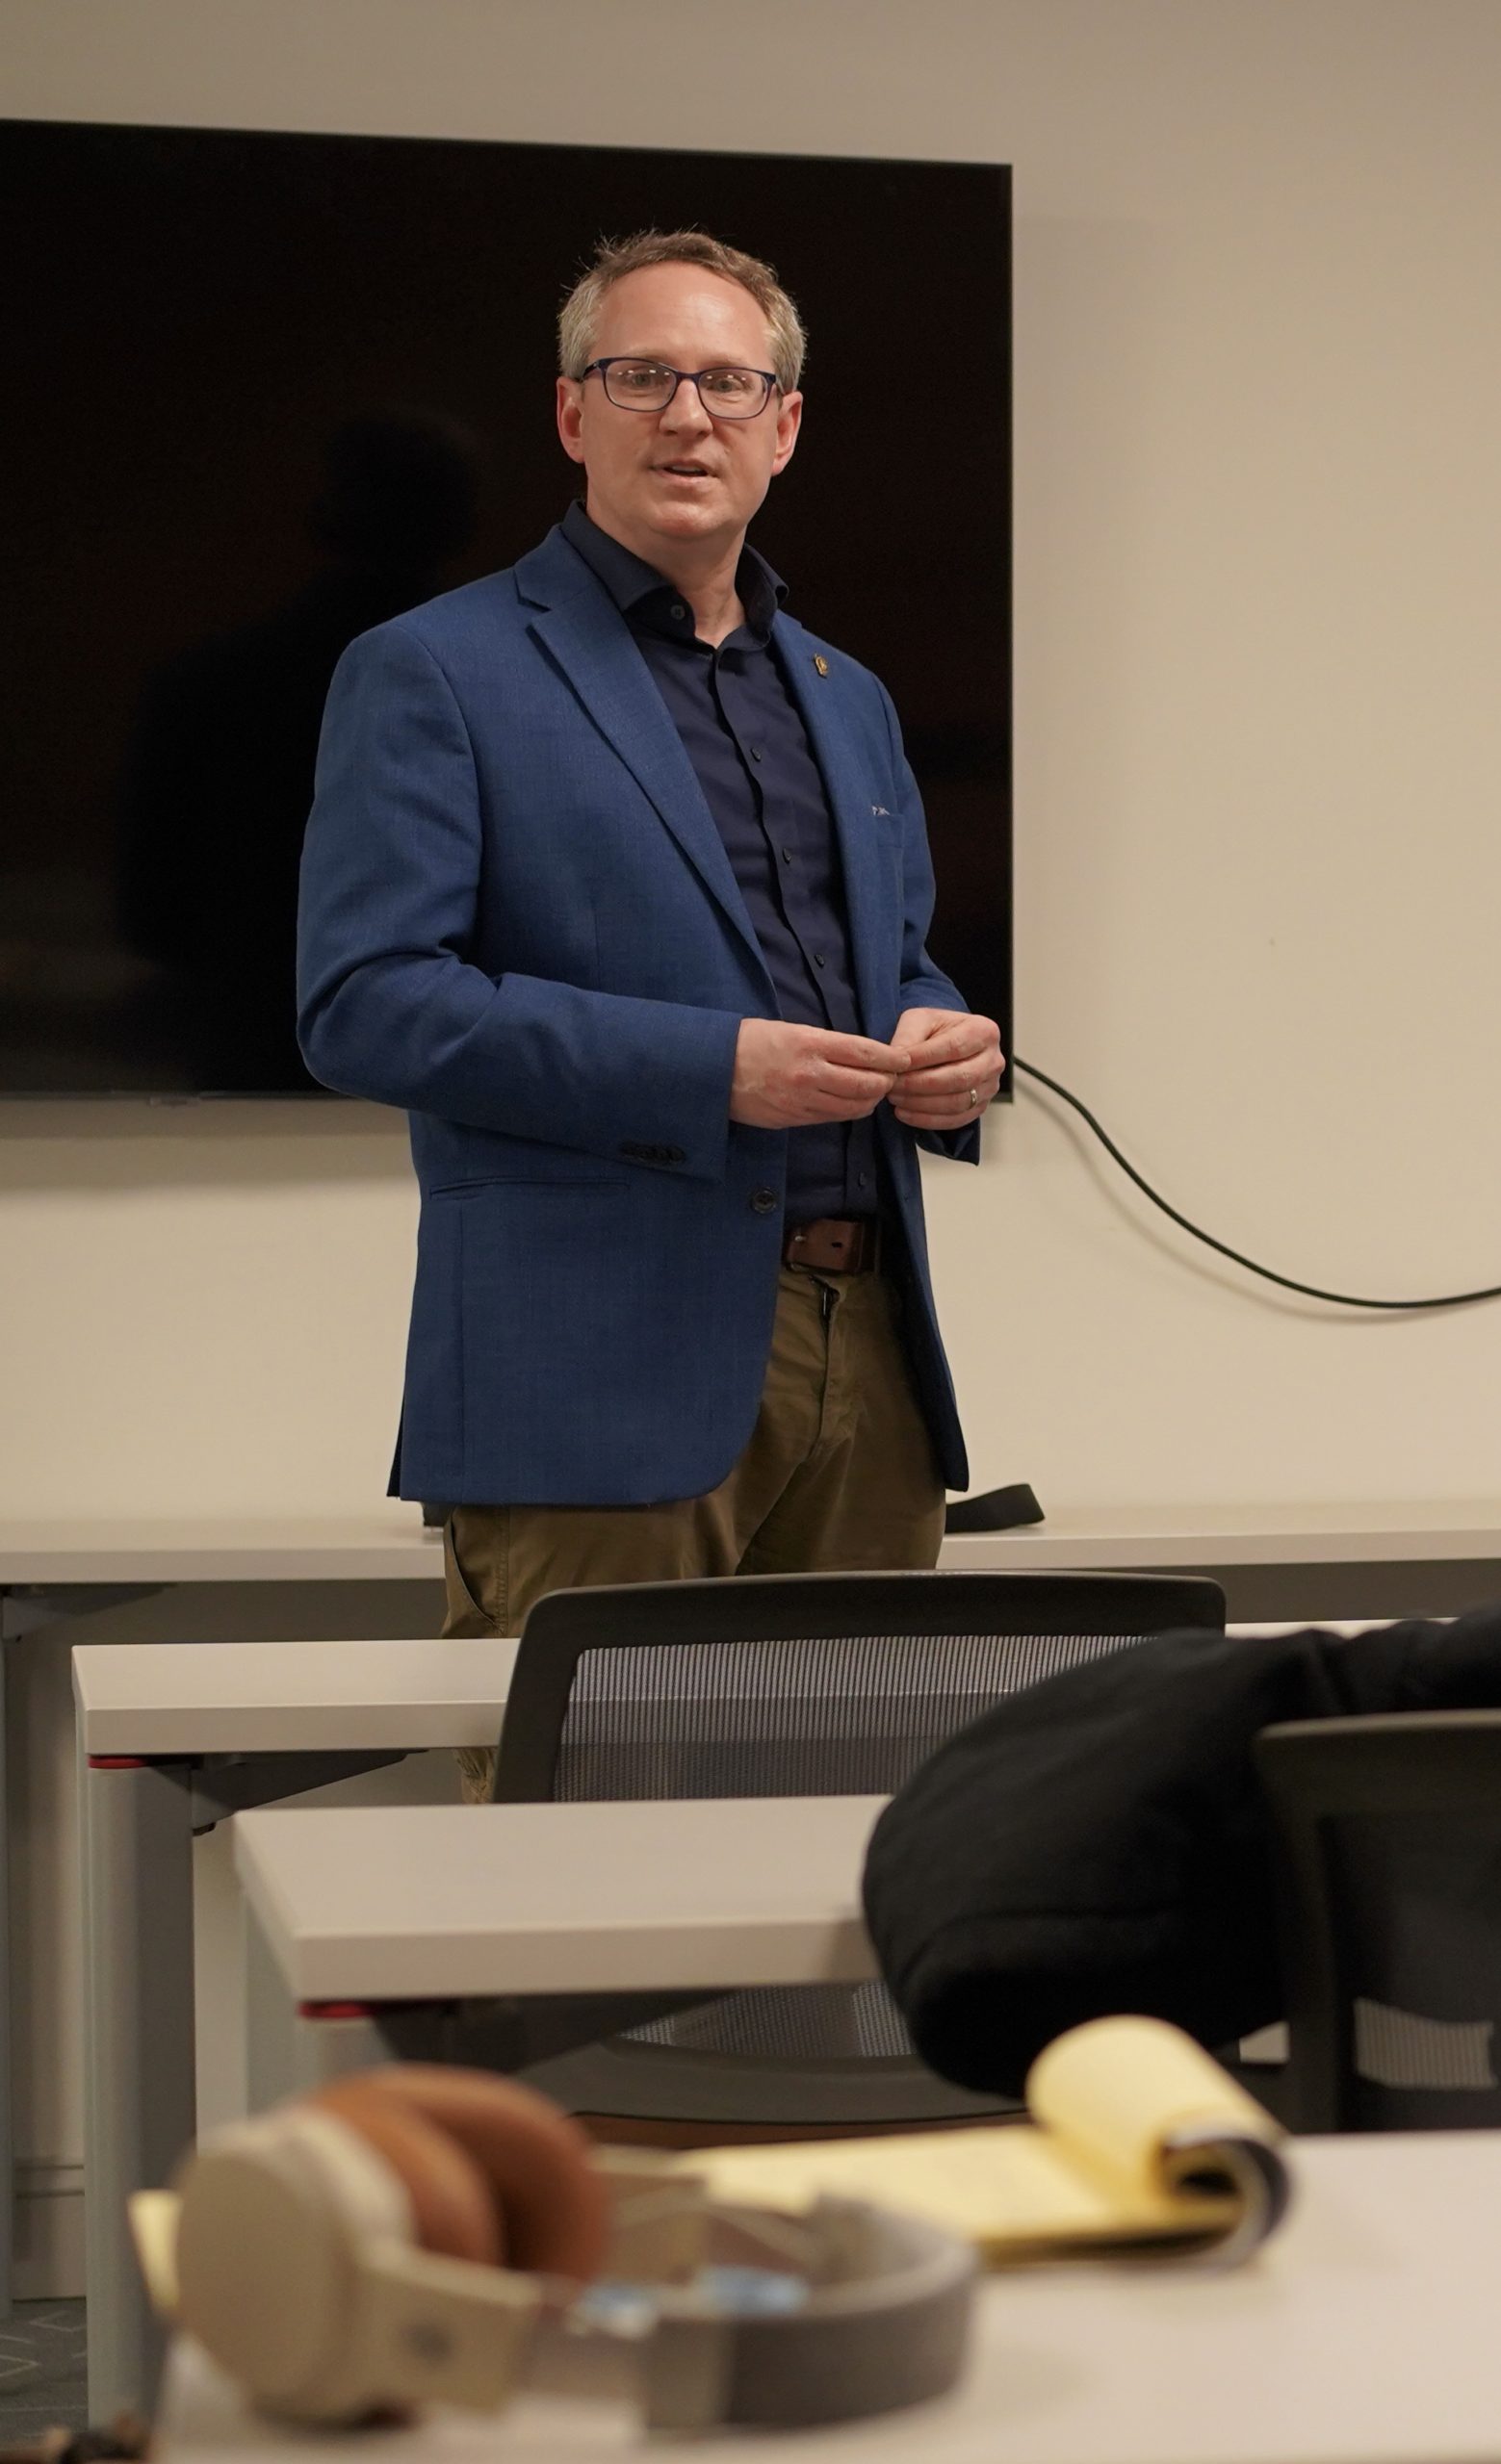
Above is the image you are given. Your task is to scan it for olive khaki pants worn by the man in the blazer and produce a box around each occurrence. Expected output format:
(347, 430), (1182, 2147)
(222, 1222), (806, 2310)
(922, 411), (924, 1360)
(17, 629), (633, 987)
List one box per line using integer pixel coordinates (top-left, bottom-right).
(444, 1267), (944, 1801)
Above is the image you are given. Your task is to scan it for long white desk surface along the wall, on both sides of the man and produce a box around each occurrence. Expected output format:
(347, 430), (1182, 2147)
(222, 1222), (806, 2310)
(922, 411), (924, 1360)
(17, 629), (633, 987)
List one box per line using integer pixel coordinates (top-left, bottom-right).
(0, 1498), (1501, 1584)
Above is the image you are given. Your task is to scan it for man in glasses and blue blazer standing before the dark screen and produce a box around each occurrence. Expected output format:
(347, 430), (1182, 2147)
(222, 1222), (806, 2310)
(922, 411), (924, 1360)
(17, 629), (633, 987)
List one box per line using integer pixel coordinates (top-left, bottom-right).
(300, 232), (1003, 1789)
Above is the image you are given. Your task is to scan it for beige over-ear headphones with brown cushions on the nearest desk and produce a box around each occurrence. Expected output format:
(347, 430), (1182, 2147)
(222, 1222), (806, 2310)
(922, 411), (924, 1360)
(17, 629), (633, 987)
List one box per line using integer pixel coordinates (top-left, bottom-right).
(172, 2065), (976, 2429)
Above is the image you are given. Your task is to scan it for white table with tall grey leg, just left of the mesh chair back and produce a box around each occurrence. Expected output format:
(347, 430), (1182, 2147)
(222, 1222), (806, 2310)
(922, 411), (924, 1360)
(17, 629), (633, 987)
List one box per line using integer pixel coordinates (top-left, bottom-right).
(74, 1638), (515, 2420)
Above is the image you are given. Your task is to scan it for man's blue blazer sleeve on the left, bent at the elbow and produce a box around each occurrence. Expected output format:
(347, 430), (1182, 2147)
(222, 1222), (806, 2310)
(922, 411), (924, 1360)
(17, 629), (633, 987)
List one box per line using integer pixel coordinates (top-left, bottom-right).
(298, 621), (739, 1180)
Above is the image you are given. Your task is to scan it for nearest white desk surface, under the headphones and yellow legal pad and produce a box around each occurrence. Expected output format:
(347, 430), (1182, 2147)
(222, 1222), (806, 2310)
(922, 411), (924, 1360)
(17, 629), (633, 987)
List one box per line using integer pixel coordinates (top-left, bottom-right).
(153, 2131), (1501, 2464)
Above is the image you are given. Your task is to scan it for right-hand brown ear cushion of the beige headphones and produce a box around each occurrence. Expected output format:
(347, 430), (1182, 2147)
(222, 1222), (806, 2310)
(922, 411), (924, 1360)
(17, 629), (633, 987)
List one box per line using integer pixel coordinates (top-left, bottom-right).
(347, 2063), (611, 2282)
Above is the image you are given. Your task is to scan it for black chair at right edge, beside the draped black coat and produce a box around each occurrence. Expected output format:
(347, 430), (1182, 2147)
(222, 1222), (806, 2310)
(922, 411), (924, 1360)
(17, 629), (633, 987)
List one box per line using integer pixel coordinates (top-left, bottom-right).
(1255, 1710), (1501, 2131)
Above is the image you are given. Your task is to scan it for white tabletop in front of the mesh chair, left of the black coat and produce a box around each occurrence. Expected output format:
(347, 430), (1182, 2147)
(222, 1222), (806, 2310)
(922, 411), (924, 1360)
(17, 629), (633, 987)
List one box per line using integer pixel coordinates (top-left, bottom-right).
(234, 1796), (885, 2001)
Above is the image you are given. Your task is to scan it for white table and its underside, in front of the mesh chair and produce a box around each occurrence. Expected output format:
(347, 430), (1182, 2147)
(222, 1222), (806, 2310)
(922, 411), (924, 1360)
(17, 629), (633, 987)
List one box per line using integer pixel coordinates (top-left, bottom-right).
(234, 1796), (885, 2139)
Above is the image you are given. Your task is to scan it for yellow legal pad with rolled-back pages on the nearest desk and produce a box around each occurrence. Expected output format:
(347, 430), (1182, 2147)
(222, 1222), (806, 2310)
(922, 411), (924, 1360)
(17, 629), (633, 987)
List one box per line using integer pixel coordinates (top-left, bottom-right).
(681, 2018), (1289, 2267)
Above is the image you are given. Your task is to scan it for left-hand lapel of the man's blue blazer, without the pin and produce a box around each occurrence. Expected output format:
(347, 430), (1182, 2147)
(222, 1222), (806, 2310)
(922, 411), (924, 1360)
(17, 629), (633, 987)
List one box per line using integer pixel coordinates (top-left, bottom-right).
(515, 532), (766, 973)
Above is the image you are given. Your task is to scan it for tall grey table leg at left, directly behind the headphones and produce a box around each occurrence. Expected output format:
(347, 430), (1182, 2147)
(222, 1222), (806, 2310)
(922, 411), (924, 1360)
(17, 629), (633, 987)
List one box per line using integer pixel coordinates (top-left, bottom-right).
(79, 1759), (194, 2422)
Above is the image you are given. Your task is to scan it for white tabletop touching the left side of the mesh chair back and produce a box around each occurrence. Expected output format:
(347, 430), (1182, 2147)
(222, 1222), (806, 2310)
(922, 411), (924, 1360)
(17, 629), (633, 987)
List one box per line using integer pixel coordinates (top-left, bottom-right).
(74, 1636), (515, 1755)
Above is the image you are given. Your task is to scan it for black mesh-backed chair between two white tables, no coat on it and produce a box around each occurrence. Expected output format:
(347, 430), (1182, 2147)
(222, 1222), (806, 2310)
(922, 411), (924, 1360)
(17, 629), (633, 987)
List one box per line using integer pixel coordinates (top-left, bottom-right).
(493, 1572), (1225, 2129)
